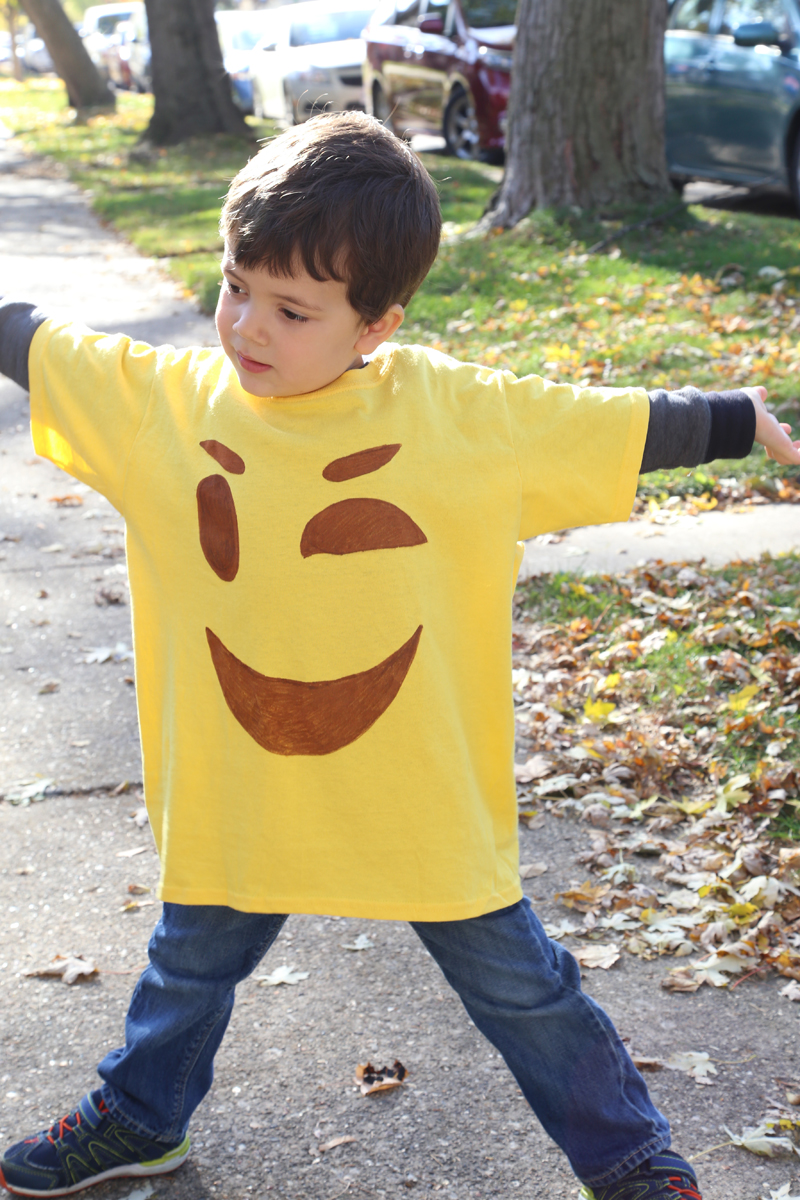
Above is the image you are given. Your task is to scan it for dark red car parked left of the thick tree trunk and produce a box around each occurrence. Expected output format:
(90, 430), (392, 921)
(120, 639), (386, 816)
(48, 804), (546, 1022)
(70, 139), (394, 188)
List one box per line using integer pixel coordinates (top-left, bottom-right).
(363, 0), (516, 162)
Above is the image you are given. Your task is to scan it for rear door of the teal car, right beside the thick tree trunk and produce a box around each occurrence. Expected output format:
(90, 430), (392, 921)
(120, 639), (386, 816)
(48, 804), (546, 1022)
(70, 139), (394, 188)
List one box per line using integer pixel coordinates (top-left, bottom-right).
(664, 0), (720, 175)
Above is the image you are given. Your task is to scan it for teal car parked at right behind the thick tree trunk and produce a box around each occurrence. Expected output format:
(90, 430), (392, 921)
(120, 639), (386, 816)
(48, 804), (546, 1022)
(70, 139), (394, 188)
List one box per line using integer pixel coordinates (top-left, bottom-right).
(664, 0), (800, 208)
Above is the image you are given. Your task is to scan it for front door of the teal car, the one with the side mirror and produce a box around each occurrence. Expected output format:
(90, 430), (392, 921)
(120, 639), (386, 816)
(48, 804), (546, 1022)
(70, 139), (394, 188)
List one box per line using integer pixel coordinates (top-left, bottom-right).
(708, 0), (798, 184)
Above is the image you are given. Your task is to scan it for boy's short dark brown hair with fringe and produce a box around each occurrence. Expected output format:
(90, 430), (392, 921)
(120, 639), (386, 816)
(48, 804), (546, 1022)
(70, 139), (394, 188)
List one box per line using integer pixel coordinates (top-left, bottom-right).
(219, 113), (441, 322)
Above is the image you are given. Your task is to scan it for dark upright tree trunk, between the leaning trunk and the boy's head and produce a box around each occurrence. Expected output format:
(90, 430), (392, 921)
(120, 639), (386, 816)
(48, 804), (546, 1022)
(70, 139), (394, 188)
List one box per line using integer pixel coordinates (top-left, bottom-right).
(145, 0), (252, 145)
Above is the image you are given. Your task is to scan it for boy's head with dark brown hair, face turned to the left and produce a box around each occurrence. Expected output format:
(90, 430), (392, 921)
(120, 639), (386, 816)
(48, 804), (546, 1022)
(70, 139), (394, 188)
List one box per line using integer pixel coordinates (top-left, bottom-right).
(217, 113), (441, 396)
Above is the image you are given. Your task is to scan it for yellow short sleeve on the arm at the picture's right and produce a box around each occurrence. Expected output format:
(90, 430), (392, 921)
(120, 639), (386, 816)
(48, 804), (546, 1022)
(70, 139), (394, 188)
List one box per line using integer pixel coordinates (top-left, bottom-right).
(503, 372), (650, 538)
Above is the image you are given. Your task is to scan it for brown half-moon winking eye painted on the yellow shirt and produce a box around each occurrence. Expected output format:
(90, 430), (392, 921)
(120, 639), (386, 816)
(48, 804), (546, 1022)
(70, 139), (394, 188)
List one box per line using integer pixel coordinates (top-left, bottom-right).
(300, 499), (428, 558)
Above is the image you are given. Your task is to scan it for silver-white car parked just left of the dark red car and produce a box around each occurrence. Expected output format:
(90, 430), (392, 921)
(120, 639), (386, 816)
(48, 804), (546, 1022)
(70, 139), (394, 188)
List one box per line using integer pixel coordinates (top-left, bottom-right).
(251, 0), (375, 125)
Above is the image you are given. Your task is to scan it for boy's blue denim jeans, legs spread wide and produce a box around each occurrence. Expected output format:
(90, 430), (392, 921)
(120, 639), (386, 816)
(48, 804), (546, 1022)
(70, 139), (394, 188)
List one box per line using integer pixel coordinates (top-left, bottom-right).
(98, 899), (669, 1187)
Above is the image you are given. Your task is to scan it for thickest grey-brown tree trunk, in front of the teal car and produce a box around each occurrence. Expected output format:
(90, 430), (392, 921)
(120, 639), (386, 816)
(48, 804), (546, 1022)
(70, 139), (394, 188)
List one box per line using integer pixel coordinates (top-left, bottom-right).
(489, 0), (669, 227)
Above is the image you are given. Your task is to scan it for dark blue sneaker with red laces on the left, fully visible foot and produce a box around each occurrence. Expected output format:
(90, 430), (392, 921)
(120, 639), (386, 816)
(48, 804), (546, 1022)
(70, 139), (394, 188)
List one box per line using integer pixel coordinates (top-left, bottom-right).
(0, 1090), (190, 1196)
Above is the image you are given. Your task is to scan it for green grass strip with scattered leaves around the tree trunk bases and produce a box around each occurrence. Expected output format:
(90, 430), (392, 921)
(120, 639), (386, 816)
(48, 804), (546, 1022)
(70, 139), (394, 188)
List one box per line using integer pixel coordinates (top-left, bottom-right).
(0, 80), (800, 499)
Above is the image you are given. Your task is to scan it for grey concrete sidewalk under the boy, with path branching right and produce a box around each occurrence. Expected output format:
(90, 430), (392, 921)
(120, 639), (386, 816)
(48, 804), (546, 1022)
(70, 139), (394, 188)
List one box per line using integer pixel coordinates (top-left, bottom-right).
(0, 131), (799, 1200)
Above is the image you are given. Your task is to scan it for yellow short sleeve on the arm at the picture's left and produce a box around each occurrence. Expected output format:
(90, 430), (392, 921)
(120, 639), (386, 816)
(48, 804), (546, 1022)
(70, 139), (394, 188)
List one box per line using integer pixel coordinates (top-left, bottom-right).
(28, 320), (158, 511)
